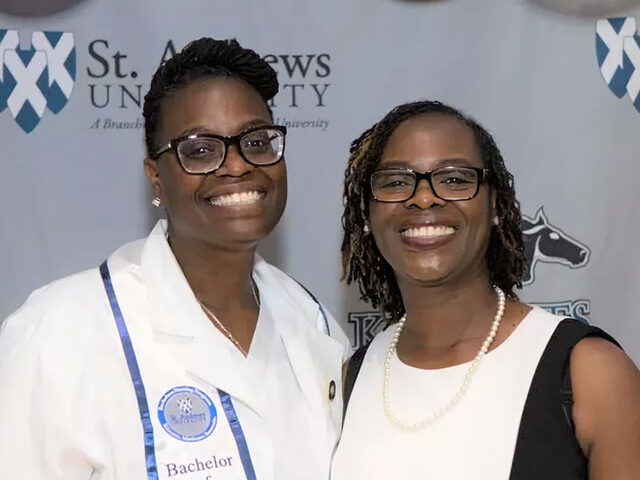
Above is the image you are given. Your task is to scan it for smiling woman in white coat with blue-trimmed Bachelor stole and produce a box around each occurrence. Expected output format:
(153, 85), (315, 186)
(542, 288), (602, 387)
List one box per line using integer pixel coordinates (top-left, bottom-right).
(0, 39), (348, 480)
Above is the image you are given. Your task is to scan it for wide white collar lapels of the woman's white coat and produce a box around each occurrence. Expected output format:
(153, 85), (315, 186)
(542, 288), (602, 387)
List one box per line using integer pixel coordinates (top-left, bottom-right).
(136, 220), (344, 408)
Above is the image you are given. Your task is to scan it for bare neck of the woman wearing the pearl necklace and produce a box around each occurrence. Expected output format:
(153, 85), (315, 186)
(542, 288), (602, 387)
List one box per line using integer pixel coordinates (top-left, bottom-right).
(398, 274), (497, 350)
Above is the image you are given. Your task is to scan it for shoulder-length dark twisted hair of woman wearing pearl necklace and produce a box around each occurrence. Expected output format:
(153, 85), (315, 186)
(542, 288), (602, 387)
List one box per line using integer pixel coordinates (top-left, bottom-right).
(341, 101), (525, 322)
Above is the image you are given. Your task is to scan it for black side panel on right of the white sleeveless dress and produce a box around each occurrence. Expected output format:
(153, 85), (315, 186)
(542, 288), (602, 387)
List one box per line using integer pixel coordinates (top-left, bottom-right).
(509, 318), (618, 480)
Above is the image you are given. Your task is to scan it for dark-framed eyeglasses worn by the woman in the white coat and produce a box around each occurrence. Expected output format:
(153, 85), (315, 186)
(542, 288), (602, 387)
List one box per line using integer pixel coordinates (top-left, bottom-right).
(150, 125), (287, 175)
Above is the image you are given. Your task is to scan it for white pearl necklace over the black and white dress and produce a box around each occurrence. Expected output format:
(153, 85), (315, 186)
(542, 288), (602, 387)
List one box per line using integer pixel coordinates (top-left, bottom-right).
(382, 287), (506, 432)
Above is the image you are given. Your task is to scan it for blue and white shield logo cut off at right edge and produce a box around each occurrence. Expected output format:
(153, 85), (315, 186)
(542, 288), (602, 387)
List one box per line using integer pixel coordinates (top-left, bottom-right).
(596, 17), (640, 112)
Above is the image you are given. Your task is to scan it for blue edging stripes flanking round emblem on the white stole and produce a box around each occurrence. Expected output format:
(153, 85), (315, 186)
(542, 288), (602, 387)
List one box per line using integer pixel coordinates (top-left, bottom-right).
(100, 260), (257, 480)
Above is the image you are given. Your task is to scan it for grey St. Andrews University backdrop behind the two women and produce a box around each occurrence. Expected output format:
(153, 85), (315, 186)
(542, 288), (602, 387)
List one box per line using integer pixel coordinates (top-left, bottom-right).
(0, 0), (640, 362)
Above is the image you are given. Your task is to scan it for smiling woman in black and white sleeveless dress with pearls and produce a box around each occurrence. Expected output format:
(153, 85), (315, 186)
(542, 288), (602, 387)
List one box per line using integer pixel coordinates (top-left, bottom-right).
(331, 101), (640, 480)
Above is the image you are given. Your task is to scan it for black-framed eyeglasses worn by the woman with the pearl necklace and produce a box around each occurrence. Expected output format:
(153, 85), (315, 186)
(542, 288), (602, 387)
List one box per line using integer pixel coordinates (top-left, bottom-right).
(371, 166), (489, 203)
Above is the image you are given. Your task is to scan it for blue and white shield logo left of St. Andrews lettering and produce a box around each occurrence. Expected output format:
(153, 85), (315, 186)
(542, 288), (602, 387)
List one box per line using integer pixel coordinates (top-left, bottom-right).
(0, 29), (76, 133)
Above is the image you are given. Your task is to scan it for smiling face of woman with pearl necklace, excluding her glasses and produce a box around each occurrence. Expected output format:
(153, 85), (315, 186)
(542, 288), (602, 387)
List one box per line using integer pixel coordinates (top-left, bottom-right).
(369, 114), (494, 285)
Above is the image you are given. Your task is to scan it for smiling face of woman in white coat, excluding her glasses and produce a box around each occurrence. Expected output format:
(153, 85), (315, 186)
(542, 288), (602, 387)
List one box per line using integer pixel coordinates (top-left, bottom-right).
(145, 77), (287, 249)
